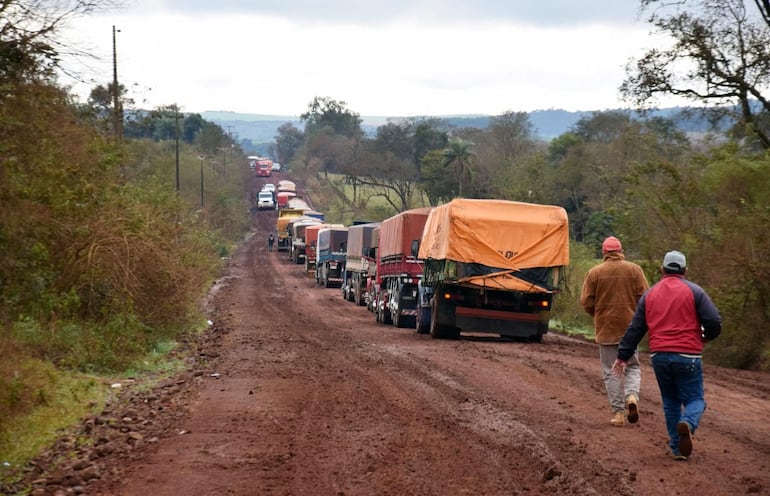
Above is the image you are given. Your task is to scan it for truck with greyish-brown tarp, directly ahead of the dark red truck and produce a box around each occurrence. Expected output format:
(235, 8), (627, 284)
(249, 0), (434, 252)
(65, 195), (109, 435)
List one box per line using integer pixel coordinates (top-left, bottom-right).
(342, 222), (380, 306)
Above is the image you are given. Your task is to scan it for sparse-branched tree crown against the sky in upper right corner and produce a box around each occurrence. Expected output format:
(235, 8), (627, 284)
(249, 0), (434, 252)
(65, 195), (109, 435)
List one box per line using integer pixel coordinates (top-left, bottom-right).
(620, 0), (770, 149)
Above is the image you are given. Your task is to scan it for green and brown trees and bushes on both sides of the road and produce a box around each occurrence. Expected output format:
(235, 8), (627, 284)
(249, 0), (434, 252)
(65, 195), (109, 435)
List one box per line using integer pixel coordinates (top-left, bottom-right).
(0, 0), (770, 488)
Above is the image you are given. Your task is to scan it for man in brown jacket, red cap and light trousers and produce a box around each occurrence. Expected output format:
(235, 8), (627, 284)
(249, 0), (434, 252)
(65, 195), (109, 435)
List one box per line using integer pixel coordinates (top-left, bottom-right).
(580, 236), (649, 426)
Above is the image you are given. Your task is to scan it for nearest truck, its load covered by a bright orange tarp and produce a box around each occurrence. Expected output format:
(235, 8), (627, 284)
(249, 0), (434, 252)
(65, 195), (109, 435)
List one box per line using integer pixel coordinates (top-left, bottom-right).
(417, 199), (569, 341)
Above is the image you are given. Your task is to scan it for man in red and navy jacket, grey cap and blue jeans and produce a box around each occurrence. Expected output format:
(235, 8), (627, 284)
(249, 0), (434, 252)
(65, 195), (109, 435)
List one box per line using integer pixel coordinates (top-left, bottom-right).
(612, 251), (722, 460)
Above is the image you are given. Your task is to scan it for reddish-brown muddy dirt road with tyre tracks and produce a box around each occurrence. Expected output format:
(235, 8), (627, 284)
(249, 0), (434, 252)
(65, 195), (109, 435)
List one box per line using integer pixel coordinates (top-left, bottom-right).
(13, 179), (770, 496)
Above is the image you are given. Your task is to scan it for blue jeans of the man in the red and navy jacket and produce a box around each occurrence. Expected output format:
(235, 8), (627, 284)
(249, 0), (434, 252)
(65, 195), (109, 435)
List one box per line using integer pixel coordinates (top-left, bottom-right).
(651, 352), (706, 453)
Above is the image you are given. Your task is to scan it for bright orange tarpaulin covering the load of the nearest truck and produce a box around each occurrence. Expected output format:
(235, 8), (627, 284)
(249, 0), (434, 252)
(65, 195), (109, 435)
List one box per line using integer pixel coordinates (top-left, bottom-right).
(419, 198), (569, 270)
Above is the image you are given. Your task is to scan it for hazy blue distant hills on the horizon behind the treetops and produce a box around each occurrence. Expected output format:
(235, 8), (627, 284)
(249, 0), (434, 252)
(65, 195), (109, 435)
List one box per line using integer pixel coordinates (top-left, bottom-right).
(201, 107), (707, 154)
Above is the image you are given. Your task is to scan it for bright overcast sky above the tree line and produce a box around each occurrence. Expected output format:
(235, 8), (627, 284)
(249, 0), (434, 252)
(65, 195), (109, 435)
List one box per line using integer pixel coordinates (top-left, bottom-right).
(61, 0), (653, 116)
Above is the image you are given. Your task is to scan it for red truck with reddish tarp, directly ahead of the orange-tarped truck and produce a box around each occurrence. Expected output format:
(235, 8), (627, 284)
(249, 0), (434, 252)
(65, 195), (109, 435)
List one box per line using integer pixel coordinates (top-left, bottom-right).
(368, 207), (432, 327)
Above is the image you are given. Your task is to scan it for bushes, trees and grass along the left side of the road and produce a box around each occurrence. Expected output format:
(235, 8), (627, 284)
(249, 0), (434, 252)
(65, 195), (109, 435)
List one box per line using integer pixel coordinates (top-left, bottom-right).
(0, 1), (249, 482)
